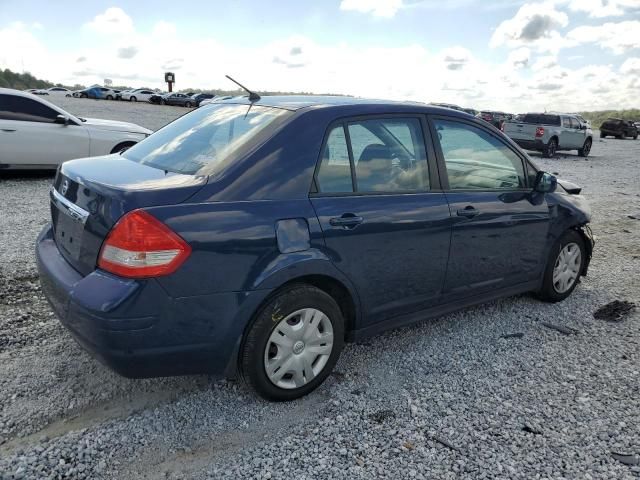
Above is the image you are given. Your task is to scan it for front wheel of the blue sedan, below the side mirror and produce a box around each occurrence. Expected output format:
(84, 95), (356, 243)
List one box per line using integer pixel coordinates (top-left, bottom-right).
(538, 230), (587, 303)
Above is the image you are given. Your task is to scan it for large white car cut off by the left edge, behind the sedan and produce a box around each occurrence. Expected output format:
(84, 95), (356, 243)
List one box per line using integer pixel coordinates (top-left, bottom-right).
(0, 88), (153, 170)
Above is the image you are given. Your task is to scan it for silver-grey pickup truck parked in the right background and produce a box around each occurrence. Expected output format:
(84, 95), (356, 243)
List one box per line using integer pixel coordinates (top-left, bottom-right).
(503, 113), (593, 158)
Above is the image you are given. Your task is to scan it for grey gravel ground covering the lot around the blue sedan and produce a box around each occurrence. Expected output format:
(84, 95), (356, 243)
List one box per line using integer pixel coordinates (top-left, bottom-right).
(0, 99), (640, 479)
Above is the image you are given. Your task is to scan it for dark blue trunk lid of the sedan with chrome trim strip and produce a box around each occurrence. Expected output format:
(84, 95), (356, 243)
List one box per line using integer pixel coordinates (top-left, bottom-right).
(50, 154), (207, 275)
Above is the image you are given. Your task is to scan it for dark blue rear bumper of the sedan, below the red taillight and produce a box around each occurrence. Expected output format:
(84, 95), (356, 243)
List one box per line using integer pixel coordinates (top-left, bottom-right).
(36, 227), (269, 377)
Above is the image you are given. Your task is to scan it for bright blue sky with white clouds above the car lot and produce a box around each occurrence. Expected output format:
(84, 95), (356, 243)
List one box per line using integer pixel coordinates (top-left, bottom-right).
(0, 0), (640, 113)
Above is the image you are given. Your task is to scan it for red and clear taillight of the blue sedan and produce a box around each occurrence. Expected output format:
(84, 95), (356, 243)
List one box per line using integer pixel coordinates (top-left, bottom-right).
(98, 210), (191, 278)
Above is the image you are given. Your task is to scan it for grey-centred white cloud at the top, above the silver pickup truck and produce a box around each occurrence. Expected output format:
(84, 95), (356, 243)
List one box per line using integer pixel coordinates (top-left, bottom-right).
(489, 2), (569, 50)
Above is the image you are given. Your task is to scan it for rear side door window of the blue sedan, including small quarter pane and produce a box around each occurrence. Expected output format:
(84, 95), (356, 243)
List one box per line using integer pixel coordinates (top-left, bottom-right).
(316, 118), (429, 193)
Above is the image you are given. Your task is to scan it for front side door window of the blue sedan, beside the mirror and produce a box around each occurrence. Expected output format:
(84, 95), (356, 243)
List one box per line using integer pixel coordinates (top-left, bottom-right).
(434, 119), (530, 190)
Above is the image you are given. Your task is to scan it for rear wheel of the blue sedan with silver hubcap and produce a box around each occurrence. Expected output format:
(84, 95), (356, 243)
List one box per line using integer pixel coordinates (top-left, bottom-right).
(238, 284), (344, 401)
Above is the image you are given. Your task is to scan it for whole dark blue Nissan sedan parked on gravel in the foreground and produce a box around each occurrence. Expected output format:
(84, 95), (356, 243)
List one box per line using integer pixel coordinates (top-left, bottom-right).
(37, 96), (593, 400)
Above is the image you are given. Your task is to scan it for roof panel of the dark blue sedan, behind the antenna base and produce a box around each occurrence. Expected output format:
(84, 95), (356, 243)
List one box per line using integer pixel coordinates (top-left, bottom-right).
(210, 95), (476, 117)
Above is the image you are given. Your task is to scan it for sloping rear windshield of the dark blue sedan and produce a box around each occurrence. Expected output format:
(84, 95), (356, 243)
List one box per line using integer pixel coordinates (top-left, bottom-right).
(122, 104), (291, 174)
